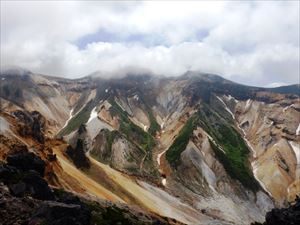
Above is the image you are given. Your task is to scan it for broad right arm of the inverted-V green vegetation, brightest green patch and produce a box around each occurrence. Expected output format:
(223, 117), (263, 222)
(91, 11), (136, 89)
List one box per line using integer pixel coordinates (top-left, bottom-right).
(198, 105), (259, 191)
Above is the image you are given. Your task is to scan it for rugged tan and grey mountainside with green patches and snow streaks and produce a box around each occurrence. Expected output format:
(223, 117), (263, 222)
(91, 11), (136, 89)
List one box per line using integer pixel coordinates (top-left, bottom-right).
(0, 71), (300, 225)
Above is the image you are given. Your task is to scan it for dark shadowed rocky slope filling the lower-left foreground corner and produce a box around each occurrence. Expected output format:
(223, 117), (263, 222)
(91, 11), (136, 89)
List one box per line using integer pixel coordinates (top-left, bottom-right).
(0, 151), (181, 225)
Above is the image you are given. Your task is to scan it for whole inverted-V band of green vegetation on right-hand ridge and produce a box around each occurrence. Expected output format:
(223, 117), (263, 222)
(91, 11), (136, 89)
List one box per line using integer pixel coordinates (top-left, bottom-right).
(166, 103), (259, 191)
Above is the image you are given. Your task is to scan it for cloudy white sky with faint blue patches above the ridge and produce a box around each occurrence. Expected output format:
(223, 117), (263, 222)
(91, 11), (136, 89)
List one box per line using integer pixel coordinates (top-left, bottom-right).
(0, 0), (300, 87)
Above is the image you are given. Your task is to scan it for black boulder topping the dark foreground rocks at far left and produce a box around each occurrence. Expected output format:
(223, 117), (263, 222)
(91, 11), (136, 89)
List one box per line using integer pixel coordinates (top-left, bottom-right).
(6, 152), (46, 176)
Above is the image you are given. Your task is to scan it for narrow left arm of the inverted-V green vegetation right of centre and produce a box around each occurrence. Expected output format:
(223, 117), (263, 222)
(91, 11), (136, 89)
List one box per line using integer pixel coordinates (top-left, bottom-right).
(166, 117), (195, 168)
